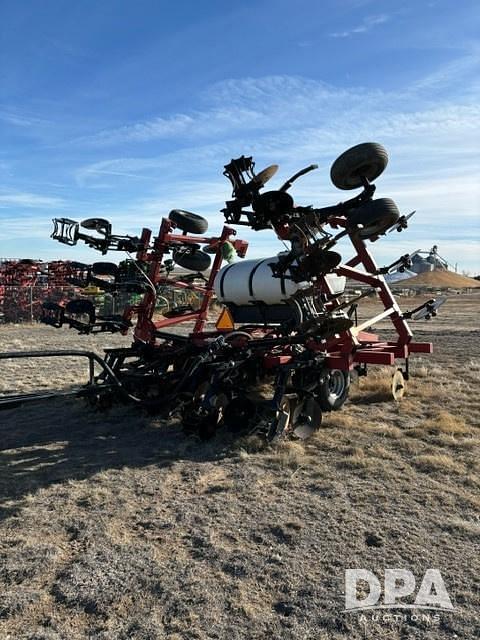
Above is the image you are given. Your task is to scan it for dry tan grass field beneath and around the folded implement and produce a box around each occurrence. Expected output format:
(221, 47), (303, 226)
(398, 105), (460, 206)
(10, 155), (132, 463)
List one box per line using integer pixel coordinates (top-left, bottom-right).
(0, 294), (480, 640)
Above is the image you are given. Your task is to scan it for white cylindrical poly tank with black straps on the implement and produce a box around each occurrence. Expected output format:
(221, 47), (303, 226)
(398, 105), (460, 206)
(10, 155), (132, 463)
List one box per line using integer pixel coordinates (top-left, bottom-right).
(214, 256), (345, 305)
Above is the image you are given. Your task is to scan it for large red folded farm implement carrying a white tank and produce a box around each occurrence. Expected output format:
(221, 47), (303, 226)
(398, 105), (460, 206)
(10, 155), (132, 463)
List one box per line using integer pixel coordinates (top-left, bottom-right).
(0, 143), (444, 441)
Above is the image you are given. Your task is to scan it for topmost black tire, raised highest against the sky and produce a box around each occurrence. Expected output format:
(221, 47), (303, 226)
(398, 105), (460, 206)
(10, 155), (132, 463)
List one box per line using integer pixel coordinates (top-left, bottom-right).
(330, 142), (388, 190)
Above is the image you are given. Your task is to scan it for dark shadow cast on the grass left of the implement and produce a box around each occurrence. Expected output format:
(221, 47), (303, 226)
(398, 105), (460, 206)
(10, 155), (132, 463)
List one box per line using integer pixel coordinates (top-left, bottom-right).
(0, 399), (232, 519)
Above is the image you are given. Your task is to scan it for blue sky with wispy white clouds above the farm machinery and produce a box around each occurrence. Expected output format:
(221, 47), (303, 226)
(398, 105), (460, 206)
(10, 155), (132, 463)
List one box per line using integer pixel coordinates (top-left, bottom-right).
(0, 0), (480, 274)
